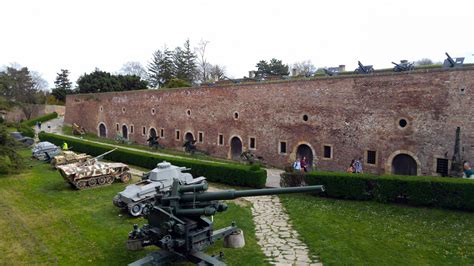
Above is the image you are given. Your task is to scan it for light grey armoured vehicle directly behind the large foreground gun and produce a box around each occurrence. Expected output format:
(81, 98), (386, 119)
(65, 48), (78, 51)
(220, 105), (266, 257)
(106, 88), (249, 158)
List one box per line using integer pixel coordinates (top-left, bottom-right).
(113, 161), (206, 217)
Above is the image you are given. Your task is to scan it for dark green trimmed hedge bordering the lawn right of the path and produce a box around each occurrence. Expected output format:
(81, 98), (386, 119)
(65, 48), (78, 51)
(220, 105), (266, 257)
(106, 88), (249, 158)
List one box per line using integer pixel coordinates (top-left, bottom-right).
(283, 172), (474, 211)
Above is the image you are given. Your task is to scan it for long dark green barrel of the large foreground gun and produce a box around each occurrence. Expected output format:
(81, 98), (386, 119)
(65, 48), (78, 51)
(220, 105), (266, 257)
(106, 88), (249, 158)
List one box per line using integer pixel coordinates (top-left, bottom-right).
(180, 186), (324, 202)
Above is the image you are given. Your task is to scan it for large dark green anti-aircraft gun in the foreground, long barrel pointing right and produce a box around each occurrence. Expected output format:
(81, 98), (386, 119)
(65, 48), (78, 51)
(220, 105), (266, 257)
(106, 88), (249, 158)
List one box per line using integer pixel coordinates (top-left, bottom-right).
(127, 180), (324, 266)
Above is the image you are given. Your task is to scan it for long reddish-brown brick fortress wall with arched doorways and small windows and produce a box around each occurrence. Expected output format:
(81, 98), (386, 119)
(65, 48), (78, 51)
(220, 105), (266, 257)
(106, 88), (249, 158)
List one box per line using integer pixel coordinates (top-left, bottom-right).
(65, 68), (474, 175)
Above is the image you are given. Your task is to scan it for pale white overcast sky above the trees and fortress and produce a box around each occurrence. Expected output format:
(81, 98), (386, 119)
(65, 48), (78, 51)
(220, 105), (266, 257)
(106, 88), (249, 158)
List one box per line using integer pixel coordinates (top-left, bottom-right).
(0, 0), (474, 87)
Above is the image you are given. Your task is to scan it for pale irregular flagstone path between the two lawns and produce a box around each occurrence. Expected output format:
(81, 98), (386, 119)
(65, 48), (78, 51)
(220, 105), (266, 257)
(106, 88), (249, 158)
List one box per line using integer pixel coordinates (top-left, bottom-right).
(246, 196), (322, 266)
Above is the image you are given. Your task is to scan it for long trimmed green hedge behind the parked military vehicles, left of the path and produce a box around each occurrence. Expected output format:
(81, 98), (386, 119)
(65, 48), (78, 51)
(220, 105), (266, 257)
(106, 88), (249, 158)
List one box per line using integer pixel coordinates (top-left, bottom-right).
(39, 132), (267, 188)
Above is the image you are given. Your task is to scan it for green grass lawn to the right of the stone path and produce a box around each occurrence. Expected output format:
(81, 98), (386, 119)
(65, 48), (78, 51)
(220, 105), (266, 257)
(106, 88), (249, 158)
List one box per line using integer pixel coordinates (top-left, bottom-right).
(280, 195), (474, 265)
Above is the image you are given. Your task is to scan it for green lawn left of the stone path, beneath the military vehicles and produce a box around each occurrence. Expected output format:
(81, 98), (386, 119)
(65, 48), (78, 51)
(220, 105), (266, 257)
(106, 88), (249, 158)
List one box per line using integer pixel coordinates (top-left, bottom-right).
(0, 150), (265, 265)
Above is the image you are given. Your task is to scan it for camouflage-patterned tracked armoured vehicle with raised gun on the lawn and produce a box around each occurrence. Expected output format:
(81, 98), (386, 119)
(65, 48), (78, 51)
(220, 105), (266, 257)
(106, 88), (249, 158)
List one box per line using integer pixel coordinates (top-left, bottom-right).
(57, 149), (132, 189)
